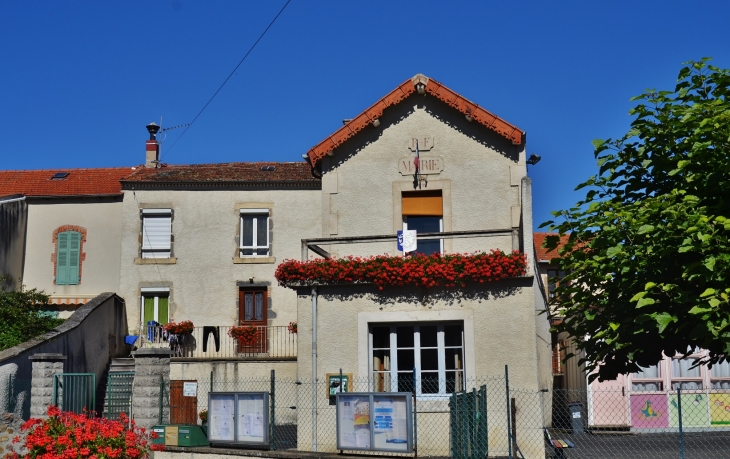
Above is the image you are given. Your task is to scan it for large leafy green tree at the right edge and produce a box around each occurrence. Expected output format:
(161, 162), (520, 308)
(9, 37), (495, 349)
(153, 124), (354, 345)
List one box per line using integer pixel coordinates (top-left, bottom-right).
(541, 58), (730, 380)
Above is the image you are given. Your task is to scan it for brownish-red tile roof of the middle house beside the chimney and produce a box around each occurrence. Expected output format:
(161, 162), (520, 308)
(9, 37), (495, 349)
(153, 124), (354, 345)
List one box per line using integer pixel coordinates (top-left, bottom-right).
(124, 162), (319, 182)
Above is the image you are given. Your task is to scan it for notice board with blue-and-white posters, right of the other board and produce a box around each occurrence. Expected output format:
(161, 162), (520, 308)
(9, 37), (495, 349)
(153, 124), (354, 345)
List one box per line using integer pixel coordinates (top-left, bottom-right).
(336, 392), (413, 453)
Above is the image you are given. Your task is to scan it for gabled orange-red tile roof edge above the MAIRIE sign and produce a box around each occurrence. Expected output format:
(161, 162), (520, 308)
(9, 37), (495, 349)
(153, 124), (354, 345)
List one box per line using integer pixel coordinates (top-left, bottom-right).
(307, 73), (525, 165)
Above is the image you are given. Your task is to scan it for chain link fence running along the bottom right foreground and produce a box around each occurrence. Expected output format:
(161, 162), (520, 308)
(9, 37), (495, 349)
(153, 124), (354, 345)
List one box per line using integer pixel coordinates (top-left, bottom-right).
(161, 373), (730, 459)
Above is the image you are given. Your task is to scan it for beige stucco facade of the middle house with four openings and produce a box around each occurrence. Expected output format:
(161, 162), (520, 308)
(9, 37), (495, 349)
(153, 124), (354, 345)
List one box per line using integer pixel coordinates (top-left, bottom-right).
(119, 189), (321, 338)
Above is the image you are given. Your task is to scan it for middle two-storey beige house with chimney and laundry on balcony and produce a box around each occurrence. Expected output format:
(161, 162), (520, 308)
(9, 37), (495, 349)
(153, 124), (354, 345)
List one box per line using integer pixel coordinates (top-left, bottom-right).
(118, 124), (322, 379)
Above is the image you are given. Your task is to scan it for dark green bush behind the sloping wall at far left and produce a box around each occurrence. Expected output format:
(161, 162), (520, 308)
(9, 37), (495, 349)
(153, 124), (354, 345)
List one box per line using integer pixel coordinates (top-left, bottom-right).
(0, 276), (63, 350)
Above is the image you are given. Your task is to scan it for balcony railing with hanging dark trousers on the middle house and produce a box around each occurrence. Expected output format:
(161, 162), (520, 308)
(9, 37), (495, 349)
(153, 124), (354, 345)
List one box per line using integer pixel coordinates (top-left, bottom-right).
(137, 325), (297, 360)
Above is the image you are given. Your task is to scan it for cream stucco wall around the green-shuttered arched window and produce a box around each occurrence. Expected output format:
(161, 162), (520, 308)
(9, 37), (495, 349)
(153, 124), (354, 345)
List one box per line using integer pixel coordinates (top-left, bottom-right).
(23, 196), (122, 318)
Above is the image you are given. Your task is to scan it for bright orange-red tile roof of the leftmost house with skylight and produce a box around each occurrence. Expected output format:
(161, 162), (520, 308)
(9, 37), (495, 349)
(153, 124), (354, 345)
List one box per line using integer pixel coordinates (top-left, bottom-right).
(0, 167), (134, 196)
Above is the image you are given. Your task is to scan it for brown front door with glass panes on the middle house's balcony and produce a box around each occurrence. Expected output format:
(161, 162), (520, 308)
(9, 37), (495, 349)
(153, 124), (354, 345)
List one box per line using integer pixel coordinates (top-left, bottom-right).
(238, 288), (269, 354)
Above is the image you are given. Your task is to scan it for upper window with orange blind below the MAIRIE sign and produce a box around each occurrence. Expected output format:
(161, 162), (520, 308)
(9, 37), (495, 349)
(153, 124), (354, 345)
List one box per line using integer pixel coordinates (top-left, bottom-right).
(401, 190), (443, 255)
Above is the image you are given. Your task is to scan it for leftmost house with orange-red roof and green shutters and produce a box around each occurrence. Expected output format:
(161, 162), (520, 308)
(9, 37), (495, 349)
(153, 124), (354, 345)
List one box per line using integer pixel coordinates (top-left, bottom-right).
(0, 167), (133, 318)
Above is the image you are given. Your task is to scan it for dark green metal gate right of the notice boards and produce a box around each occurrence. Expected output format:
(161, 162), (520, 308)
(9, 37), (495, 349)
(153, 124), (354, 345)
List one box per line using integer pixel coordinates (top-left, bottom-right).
(449, 386), (489, 459)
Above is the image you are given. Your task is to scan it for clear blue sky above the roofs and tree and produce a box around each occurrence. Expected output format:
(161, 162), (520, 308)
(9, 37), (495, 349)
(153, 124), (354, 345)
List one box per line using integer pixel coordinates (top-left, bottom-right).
(0, 0), (730, 224)
